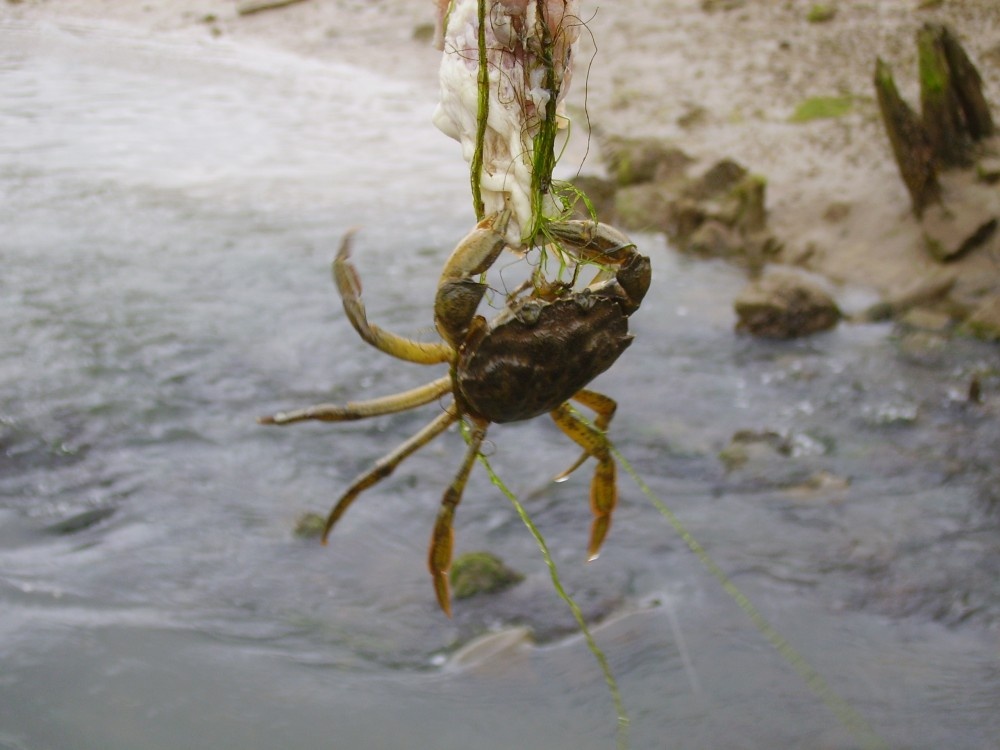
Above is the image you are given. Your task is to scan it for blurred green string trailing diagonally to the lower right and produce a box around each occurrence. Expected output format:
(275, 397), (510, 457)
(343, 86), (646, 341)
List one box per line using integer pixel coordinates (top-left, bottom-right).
(609, 442), (889, 750)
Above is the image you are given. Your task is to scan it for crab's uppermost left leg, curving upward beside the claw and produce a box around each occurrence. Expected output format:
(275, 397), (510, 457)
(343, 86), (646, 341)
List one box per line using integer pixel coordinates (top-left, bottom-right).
(333, 230), (454, 365)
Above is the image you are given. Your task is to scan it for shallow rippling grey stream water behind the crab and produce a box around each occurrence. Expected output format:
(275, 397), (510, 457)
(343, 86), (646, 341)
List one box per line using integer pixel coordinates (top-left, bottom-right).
(0, 21), (1000, 750)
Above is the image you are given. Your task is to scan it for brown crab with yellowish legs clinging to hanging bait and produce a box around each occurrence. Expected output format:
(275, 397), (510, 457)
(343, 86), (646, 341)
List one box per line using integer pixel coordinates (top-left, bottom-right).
(259, 209), (651, 617)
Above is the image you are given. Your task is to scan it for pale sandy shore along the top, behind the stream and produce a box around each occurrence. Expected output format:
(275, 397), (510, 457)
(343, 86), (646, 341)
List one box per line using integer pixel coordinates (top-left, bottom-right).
(7, 0), (1000, 316)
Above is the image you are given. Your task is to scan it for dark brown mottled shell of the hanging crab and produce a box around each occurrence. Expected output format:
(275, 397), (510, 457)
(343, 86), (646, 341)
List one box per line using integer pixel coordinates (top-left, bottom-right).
(453, 294), (632, 422)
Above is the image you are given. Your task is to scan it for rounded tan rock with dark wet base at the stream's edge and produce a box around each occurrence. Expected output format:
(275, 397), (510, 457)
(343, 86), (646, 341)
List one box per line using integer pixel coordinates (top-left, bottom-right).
(734, 270), (841, 339)
